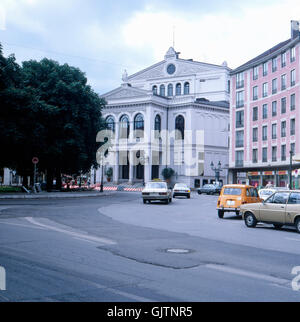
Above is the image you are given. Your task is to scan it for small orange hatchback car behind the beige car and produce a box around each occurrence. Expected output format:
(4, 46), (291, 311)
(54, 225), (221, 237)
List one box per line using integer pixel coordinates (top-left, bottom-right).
(217, 184), (262, 218)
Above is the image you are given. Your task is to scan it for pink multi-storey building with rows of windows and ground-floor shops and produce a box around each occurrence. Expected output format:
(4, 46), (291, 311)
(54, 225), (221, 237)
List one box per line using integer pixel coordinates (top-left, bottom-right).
(229, 21), (300, 187)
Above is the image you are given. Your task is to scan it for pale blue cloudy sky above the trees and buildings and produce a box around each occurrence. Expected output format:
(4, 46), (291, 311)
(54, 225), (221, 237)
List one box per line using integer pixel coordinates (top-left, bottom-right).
(0, 0), (300, 95)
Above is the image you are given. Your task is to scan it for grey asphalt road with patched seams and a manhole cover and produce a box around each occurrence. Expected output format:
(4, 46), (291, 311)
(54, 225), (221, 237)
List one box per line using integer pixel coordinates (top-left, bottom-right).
(0, 192), (300, 302)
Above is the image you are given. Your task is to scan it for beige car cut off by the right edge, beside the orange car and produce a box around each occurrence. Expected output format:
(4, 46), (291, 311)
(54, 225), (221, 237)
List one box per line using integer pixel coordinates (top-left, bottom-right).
(241, 190), (300, 233)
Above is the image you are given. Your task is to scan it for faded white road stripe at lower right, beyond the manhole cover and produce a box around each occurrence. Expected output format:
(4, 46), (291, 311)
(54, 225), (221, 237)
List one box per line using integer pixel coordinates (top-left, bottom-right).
(205, 264), (291, 285)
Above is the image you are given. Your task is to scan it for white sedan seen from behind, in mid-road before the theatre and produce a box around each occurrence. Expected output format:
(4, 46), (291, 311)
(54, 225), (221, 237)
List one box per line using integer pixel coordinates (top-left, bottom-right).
(142, 181), (172, 204)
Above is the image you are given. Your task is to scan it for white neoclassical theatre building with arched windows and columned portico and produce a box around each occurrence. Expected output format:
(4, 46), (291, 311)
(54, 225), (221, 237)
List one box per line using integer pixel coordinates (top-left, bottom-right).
(95, 47), (230, 187)
